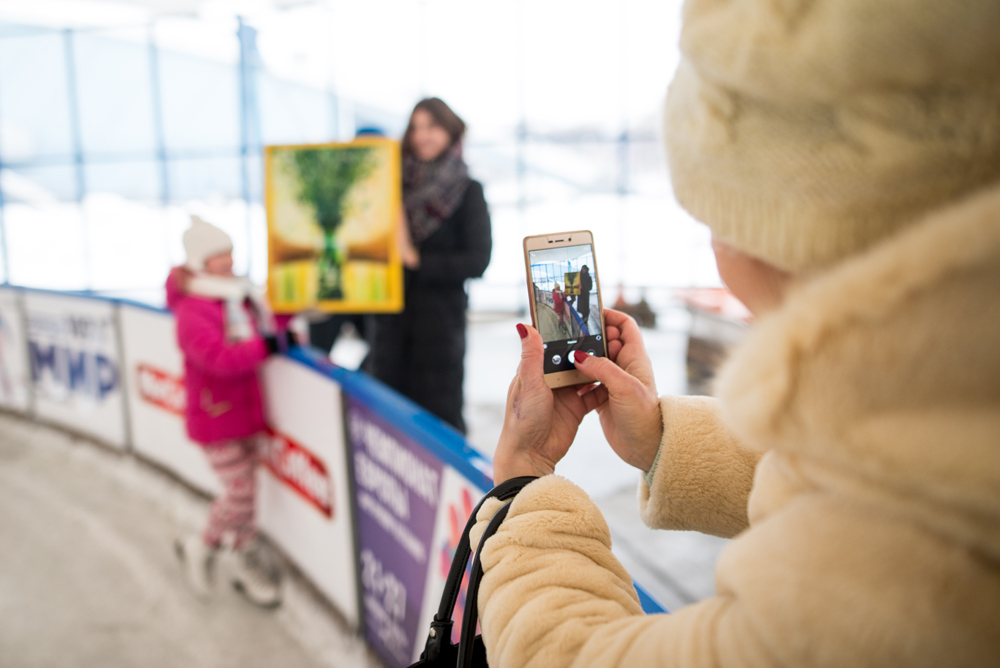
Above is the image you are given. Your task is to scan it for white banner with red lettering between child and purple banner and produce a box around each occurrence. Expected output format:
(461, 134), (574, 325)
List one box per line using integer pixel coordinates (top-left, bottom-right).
(257, 357), (360, 627)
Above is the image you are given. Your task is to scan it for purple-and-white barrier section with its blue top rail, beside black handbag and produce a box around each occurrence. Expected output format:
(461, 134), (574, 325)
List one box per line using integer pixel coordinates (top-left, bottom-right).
(289, 348), (493, 667)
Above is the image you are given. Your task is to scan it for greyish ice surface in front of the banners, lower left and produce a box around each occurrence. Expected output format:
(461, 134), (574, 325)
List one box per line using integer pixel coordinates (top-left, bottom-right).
(0, 415), (379, 668)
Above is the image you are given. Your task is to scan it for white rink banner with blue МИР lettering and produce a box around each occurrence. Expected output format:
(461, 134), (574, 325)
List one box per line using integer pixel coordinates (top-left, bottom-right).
(24, 291), (127, 449)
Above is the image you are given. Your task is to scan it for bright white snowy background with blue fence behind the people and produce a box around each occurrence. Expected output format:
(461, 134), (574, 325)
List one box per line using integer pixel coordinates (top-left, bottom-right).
(0, 0), (720, 312)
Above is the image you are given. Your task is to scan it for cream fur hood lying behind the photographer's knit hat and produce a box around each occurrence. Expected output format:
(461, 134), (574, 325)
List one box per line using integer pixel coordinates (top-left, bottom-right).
(717, 181), (1000, 558)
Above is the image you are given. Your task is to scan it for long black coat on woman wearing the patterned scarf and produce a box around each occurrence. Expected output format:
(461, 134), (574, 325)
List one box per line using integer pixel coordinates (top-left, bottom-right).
(366, 181), (493, 433)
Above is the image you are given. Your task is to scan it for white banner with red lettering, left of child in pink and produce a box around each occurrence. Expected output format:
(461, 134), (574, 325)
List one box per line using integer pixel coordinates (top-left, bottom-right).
(119, 304), (222, 495)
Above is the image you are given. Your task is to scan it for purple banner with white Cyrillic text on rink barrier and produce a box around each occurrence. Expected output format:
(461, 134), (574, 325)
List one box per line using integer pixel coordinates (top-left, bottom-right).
(348, 398), (443, 668)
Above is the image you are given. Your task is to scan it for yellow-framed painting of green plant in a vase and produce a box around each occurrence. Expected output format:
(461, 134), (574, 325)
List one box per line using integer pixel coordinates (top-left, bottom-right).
(264, 138), (403, 313)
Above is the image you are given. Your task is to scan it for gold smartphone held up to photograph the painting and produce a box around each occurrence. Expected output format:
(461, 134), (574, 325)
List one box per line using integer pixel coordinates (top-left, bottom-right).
(524, 230), (608, 388)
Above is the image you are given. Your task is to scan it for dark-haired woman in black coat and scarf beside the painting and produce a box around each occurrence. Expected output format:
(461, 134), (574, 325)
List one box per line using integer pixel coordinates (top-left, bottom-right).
(367, 98), (492, 433)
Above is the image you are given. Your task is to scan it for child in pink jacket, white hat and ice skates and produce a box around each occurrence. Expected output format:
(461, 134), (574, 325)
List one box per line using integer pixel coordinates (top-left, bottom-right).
(167, 216), (284, 607)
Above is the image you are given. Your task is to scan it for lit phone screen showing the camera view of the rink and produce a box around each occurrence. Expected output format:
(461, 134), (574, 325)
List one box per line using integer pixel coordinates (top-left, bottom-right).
(528, 244), (604, 373)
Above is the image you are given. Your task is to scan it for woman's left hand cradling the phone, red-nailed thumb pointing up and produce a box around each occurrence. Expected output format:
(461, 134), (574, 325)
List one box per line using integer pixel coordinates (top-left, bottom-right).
(493, 325), (607, 484)
